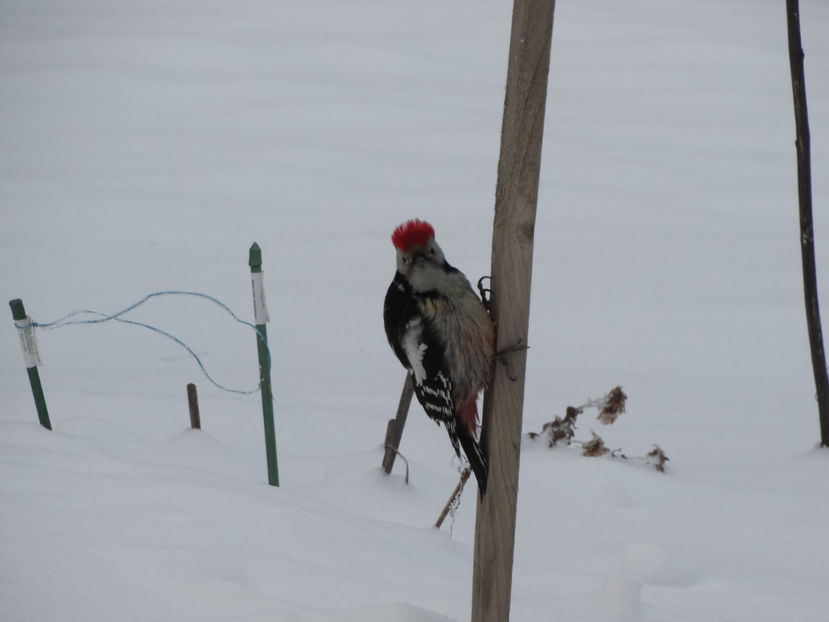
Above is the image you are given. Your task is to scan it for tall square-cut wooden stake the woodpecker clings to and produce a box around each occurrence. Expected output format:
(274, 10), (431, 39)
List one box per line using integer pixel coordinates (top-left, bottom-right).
(472, 0), (555, 622)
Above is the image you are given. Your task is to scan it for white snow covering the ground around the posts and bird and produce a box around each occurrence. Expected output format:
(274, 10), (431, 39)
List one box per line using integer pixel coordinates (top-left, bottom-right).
(0, 0), (829, 622)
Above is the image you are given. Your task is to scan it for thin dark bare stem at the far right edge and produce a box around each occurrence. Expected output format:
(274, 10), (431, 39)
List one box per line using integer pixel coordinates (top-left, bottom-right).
(786, 0), (829, 447)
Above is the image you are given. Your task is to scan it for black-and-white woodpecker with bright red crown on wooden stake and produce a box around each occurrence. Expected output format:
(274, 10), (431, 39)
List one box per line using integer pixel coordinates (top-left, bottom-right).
(383, 219), (495, 495)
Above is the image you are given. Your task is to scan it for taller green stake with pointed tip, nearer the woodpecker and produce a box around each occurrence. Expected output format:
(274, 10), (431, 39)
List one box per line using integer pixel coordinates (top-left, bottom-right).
(248, 242), (279, 486)
